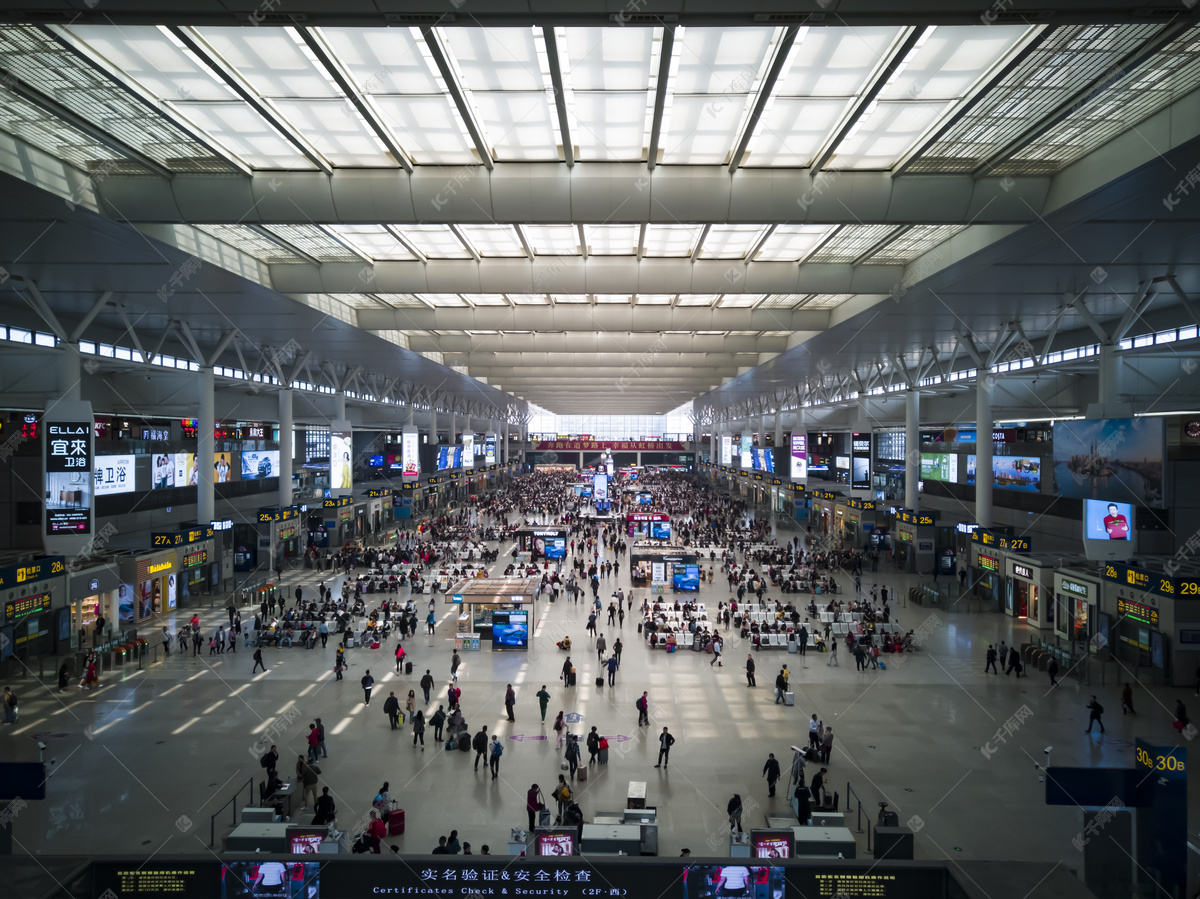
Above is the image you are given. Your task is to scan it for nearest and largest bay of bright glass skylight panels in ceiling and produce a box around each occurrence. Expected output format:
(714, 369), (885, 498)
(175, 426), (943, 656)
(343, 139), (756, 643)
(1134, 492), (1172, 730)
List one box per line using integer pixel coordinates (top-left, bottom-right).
(0, 24), (1171, 176)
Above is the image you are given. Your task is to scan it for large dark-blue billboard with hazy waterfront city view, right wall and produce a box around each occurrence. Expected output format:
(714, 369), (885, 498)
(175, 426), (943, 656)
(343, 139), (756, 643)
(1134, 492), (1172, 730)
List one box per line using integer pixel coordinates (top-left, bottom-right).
(1054, 418), (1165, 508)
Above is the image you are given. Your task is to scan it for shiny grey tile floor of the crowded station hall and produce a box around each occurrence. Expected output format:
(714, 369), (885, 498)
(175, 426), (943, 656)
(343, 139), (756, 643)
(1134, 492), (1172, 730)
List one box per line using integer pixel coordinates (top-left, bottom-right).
(0, 511), (1196, 868)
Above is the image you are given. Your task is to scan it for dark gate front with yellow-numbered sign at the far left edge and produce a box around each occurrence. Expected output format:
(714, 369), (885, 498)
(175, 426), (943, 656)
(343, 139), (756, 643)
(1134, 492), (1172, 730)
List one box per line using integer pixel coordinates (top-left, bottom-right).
(0, 556), (64, 661)
